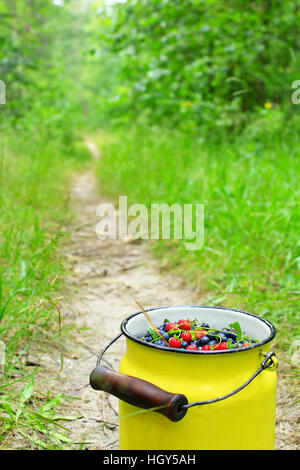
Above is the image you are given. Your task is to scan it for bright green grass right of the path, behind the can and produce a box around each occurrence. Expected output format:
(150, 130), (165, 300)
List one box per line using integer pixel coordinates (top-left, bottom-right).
(98, 116), (300, 351)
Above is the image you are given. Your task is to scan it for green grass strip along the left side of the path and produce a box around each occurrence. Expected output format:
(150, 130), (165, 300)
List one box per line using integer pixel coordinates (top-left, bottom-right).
(0, 132), (88, 449)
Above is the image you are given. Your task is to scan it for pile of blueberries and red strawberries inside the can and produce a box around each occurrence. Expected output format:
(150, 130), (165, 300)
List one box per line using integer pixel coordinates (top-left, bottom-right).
(139, 319), (259, 351)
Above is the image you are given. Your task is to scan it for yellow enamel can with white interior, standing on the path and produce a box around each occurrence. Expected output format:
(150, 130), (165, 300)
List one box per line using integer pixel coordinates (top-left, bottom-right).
(90, 306), (276, 450)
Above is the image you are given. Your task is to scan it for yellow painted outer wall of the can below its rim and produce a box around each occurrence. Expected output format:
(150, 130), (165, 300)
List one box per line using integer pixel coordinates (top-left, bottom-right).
(119, 339), (276, 450)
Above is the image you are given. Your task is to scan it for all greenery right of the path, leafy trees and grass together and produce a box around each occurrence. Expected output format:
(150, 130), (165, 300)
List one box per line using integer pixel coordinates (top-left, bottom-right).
(91, 0), (300, 352)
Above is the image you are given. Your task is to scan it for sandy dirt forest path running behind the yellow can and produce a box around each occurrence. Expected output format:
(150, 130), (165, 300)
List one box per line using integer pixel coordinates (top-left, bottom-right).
(24, 141), (296, 450)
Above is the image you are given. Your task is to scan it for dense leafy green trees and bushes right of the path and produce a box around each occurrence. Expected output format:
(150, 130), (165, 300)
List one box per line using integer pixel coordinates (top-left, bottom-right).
(95, 0), (300, 131)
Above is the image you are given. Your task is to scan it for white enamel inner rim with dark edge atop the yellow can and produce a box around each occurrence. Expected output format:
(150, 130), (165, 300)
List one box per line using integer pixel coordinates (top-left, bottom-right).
(121, 305), (276, 355)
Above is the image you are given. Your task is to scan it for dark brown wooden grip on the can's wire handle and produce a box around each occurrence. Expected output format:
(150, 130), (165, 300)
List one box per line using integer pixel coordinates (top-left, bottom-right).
(90, 366), (188, 421)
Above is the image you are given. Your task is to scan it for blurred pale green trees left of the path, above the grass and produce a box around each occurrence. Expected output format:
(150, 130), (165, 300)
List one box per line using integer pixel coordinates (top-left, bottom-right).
(0, 0), (84, 140)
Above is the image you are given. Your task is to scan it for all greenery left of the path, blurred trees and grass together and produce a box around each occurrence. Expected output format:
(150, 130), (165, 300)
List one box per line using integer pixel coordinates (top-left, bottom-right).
(0, 0), (91, 449)
